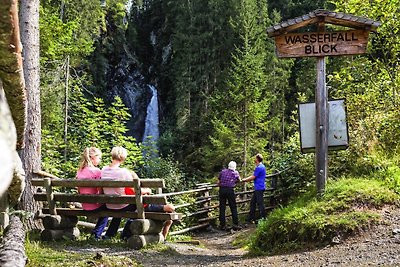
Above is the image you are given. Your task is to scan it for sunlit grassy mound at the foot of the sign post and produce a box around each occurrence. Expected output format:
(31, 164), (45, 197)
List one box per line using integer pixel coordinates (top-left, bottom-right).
(250, 178), (399, 254)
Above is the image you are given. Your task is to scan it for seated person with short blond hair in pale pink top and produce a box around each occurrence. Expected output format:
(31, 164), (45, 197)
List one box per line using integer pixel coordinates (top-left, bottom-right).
(101, 146), (136, 239)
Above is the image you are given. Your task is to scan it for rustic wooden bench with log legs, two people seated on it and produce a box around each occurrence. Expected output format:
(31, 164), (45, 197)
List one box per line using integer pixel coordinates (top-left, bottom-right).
(32, 178), (182, 249)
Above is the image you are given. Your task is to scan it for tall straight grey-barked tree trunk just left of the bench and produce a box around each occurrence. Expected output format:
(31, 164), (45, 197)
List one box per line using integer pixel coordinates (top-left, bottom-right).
(20, 0), (41, 229)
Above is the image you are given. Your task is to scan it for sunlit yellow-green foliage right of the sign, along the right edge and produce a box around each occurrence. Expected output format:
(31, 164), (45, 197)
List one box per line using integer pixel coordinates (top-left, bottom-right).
(329, 0), (400, 157)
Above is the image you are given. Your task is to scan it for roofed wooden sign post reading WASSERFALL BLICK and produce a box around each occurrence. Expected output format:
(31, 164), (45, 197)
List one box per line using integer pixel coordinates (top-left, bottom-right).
(267, 10), (380, 194)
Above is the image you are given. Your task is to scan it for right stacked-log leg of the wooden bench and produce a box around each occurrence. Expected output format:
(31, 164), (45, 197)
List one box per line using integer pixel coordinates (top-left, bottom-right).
(128, 219), (164, 249)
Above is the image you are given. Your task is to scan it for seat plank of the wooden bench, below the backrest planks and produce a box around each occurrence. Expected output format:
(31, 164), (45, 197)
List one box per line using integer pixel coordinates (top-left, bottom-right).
(42, 208), (182, 221)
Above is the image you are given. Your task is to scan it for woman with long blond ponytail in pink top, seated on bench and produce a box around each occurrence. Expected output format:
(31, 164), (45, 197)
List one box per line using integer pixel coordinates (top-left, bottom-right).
(76, 147), (108, 240)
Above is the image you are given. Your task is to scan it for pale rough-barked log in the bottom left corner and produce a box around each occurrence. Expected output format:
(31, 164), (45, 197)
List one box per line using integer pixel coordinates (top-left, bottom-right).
(0, 215), (26, 267)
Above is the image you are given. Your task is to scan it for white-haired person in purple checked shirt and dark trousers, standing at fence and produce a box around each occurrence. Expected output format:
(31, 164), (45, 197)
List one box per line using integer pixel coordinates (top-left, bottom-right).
(218, 161), (240, 230)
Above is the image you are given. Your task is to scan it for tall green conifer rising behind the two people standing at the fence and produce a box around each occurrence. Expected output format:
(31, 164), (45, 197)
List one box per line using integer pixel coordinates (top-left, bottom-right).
(206, 0), (284, 176)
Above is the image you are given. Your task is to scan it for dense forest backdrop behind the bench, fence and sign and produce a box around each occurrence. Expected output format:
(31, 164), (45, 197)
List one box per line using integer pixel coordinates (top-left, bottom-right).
(40, 0), (400, 201)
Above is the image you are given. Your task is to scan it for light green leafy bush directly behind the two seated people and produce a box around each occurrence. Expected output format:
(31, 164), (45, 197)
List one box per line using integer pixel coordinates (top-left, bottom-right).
(42, 87), (143, 177)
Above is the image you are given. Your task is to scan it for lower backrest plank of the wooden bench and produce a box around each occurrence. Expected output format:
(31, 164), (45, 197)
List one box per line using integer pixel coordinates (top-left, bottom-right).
(33, 193), (167, 205)
